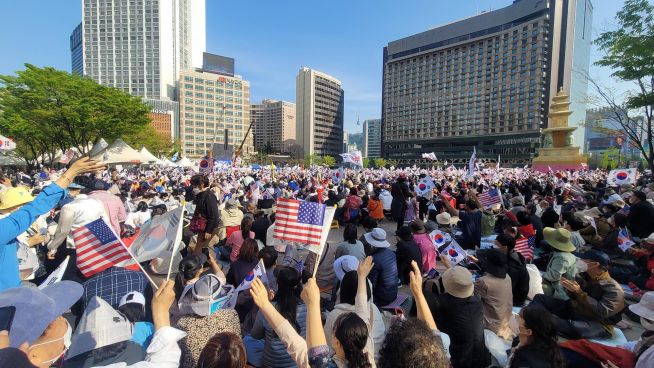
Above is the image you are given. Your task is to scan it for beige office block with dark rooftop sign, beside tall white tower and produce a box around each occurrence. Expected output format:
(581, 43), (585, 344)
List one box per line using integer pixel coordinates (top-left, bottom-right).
(179, 69), (254, 158)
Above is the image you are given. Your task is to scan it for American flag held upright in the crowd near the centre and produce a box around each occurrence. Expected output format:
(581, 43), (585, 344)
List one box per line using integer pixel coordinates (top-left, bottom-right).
(273, 198), (325, 247)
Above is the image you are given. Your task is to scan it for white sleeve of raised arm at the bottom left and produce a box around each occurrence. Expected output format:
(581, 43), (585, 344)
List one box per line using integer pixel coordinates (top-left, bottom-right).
(92, 326), (186, 368)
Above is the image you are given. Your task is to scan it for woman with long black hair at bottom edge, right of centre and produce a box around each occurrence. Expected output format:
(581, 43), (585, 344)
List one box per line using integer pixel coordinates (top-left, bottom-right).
(509, 305), (566, 368)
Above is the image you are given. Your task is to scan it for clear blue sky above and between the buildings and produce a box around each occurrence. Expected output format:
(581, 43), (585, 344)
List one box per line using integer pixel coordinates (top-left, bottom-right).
(0, 0), (623, 133)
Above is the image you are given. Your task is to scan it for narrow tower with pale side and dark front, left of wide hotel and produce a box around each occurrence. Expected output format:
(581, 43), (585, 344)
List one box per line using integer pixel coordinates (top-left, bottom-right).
(295, 67), (344, 156)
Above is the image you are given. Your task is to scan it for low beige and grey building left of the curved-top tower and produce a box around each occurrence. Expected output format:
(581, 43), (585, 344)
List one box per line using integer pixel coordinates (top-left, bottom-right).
(250, 100), (296, 153)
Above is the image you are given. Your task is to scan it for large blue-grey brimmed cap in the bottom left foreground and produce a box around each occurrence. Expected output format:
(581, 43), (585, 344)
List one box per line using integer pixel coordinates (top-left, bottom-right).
(0, 281), (84, 348)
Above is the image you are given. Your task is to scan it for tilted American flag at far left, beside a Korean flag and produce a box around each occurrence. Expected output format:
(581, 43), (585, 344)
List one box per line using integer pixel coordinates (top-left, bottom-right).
(72, 219), (131, 277)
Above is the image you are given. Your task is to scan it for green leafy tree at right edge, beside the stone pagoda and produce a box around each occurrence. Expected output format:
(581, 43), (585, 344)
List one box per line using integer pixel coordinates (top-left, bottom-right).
(589, 0), (654, 170)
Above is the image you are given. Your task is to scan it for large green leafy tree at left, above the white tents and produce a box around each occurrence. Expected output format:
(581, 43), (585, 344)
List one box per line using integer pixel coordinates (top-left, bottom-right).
(0, 64), (150, 165)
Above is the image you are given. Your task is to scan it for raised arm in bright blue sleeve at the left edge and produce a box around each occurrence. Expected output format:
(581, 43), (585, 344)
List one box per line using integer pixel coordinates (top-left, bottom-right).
(0, 157), (104, 291)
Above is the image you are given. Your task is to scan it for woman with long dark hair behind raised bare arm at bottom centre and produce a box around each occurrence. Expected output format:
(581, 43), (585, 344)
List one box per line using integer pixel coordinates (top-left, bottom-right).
(246, 267), (306, 368)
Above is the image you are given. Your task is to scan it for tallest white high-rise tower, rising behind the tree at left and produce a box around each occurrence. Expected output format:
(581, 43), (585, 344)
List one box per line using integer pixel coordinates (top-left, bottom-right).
(71, 0), (206, 100)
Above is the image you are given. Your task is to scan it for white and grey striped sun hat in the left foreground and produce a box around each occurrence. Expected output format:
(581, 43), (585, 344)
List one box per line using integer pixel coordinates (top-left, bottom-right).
(178, 274), (234, 317)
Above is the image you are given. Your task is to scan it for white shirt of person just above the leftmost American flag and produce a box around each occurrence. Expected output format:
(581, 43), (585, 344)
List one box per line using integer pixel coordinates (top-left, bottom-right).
(48, 194), (111, 251)
